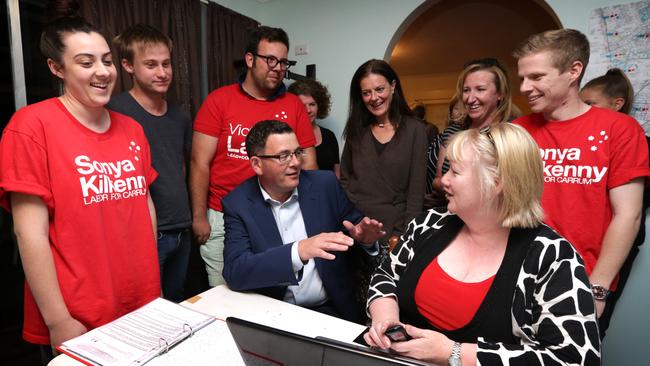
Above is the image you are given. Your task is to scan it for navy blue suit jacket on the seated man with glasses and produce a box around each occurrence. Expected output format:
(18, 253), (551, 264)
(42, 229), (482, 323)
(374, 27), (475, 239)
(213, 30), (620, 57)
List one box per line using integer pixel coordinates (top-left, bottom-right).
(222, 170), (367, 321)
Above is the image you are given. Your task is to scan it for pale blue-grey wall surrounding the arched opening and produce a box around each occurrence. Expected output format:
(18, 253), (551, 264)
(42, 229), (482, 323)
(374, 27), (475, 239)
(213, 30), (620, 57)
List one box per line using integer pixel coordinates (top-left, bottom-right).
(212, 0), (650, 365)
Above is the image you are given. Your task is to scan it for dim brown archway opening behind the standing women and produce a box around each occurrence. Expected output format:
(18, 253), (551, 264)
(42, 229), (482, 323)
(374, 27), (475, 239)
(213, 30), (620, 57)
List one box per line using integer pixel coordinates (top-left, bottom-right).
(384, 0), (562, 128)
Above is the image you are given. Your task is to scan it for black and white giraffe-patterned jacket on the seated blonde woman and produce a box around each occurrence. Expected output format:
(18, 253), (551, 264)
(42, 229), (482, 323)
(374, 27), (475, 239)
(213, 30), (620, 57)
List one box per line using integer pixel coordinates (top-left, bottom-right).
(368, 209), (600, 365)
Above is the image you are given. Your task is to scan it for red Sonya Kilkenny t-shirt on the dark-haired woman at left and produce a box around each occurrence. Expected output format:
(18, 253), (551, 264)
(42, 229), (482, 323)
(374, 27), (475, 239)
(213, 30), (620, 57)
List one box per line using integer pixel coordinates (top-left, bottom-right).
(0, 98), (160, 344)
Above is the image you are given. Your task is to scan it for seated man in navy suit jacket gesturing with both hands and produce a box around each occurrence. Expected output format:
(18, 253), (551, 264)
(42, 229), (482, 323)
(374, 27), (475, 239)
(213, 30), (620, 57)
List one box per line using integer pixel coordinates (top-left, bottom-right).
(223, 121), (385, 321)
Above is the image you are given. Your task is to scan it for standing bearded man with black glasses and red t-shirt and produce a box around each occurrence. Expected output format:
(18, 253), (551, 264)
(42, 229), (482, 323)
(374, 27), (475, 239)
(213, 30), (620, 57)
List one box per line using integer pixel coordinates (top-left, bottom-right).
(190, 26), (317, 286)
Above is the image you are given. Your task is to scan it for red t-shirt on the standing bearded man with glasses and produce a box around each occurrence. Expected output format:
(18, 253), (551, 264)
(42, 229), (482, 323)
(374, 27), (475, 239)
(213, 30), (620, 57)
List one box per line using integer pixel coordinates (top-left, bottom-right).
(194, 84), (316, 211)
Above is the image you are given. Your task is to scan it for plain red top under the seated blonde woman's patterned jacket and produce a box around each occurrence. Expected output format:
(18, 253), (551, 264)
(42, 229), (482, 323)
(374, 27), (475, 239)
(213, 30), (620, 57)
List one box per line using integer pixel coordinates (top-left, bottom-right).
(415, 257), (494, 330)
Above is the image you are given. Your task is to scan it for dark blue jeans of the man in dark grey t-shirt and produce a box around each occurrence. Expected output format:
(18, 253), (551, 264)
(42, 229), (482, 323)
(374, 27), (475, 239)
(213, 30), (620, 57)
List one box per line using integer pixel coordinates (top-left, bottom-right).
(158, 229), (190, 302)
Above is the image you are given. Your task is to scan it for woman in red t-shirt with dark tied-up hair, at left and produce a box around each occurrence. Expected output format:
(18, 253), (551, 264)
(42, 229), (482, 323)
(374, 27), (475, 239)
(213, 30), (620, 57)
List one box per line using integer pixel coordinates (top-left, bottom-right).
(0, 4), (160, 360)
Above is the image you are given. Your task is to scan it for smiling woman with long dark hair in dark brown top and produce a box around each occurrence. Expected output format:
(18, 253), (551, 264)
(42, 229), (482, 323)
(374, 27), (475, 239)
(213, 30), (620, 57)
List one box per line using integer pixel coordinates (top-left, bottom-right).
(341, 60), (427, 243)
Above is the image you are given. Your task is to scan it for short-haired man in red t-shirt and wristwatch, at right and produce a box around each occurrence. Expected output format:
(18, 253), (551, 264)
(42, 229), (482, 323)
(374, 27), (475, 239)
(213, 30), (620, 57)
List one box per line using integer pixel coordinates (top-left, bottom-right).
(513, 29), (650, 334)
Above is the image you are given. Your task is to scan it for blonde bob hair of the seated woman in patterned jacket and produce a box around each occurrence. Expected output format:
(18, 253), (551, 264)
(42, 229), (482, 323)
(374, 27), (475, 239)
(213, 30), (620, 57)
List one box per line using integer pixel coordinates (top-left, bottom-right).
(447, 123), (544, 228)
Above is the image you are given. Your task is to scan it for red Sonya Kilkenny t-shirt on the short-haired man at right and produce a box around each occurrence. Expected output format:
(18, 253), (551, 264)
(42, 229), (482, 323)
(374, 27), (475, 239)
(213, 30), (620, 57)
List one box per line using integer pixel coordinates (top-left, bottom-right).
(514, 107), (650, 280)
